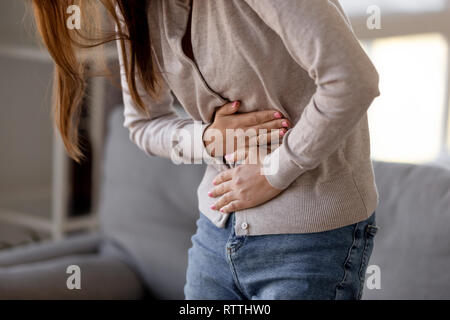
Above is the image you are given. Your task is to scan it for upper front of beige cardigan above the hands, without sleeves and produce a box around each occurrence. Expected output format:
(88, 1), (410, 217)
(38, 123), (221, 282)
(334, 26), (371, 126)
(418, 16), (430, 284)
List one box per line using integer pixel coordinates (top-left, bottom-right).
(150, 0), (316, 123)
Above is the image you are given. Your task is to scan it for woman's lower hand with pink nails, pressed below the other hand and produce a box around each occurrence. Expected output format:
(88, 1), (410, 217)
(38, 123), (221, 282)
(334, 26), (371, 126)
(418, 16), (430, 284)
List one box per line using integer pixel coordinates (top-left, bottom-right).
(208, 164), (283, 213)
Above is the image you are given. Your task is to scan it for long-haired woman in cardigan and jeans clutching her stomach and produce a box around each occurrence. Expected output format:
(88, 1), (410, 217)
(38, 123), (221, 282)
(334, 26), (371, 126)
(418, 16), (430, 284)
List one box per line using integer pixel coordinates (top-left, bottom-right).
(33, 0), (379, 299)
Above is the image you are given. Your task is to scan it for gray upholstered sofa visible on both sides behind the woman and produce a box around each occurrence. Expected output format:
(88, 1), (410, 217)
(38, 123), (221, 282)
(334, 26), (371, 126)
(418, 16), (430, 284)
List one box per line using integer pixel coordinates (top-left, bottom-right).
(0, 109), (450, 299)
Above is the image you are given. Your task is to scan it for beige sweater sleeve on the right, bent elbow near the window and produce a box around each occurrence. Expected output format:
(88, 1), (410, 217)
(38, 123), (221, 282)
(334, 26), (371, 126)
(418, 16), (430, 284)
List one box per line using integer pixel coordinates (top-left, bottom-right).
(245, 0), (380, 189)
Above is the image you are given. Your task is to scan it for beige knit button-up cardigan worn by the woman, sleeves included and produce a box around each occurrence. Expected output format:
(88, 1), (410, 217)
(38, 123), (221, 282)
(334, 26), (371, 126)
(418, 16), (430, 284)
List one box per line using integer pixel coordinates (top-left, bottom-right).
(121, 0), (379, 235)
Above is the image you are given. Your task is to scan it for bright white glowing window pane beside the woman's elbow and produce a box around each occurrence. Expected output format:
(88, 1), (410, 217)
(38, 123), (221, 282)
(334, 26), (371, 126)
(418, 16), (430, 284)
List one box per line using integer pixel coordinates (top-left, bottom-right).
(366, 34), (448, 163)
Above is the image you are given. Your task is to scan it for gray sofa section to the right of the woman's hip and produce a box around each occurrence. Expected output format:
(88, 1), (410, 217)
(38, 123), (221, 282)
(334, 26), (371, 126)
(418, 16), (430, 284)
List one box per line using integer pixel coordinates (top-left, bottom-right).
(363, 162), (450, 299)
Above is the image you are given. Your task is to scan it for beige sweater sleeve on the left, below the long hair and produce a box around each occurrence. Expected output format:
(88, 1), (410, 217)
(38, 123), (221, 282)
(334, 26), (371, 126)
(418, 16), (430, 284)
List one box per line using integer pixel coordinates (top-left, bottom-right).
(118, 26), (221, 164)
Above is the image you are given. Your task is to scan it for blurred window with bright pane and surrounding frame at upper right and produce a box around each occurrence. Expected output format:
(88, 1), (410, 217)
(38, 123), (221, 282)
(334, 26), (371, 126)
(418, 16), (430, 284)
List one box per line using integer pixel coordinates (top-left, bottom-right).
(340, 0), (450, 163)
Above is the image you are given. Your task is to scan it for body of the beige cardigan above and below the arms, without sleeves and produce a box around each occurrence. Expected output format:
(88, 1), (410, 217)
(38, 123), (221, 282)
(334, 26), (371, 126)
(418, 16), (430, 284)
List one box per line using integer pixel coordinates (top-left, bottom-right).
(149, 0), (377, 234)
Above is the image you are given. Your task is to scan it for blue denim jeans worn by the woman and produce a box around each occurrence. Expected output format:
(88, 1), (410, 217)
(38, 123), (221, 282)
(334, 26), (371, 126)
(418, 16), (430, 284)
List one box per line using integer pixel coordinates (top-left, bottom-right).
(184, 213), (377, 300)
